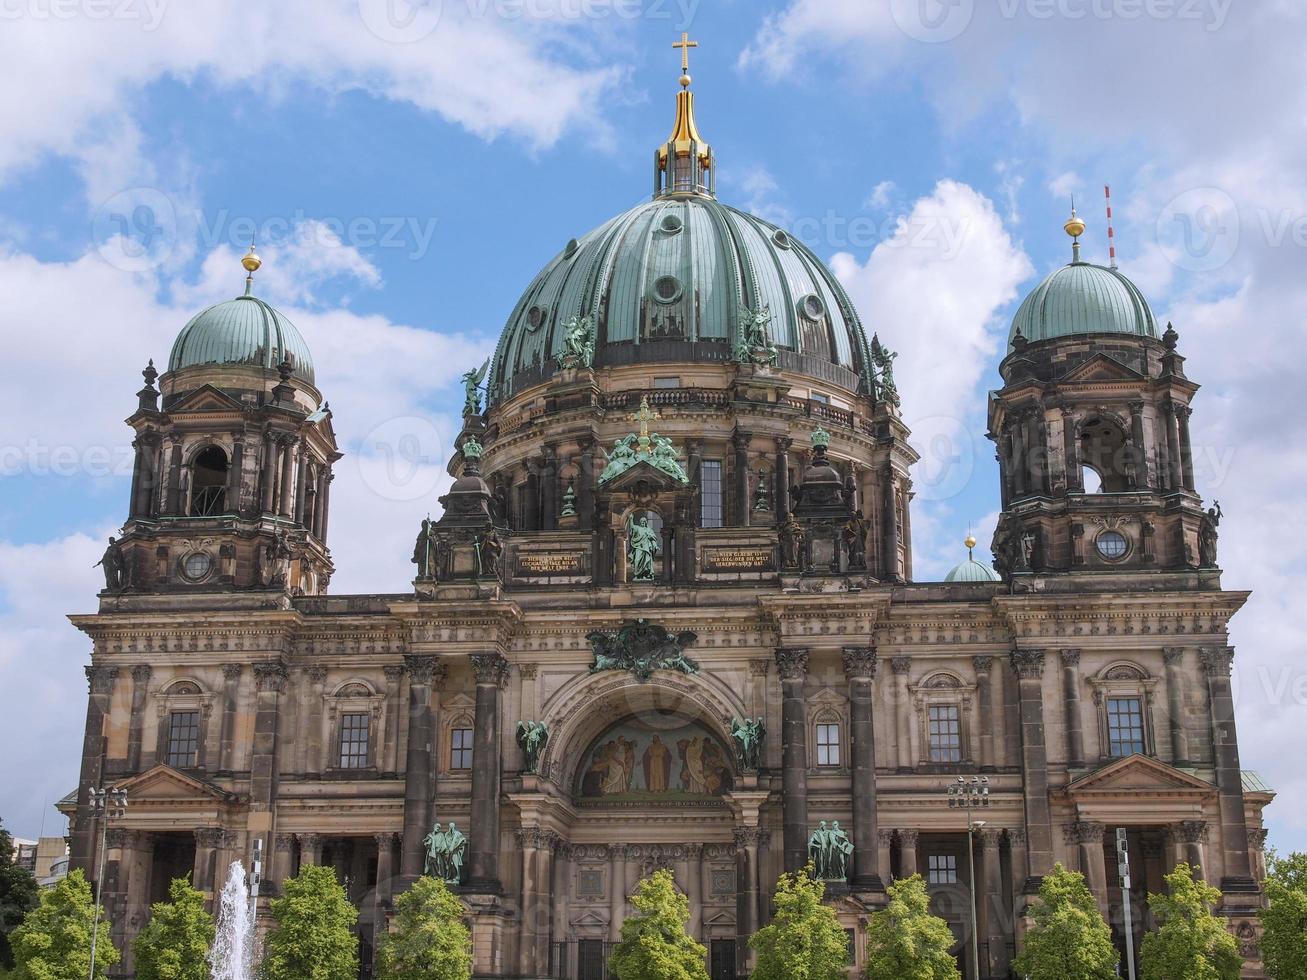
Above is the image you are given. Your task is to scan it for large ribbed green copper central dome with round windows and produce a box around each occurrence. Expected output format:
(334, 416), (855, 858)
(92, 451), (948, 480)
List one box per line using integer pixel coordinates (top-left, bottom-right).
(489, 192), (869, 401)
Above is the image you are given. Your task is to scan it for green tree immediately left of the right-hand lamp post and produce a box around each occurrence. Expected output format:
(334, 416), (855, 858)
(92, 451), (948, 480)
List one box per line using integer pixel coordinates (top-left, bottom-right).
(867, 874), (962, 980)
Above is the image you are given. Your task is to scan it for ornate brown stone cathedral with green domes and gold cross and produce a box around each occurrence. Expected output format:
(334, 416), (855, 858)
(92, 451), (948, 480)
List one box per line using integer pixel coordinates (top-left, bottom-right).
(63, 38), (1273, 980)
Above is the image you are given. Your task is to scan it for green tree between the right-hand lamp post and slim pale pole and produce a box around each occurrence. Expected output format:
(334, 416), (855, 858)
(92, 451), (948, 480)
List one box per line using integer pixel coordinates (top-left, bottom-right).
(1013, 864), (1120, 980)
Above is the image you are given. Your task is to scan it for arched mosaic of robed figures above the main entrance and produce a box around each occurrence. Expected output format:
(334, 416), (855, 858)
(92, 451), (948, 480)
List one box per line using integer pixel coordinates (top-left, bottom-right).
(576, 719), (733, 804)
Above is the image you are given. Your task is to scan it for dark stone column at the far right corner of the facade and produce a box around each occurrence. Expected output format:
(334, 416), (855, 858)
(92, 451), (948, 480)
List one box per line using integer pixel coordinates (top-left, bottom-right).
(1199, 647), (1257, 894)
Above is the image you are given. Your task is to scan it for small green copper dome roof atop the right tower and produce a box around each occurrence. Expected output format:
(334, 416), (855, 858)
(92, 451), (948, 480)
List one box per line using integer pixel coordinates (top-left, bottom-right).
(1008, 261), (1158, 349)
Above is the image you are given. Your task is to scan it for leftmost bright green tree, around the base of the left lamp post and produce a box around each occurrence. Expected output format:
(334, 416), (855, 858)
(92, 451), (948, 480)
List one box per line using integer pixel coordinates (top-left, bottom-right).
(9, 868), (118, 980)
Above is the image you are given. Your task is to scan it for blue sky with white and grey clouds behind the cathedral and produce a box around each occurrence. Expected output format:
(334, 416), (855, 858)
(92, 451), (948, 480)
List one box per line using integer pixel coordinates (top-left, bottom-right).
(0, 0), (1307, 848)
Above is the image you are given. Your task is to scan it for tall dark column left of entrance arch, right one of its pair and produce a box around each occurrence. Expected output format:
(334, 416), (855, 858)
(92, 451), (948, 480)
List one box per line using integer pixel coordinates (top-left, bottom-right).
(468, 653), (508, 892)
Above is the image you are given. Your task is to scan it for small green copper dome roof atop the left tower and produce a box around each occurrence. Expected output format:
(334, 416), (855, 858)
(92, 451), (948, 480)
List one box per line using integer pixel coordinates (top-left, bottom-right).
(169, 297), (314, 384)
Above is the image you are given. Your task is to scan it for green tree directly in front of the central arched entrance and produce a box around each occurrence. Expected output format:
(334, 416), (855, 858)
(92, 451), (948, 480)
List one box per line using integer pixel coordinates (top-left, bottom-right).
(608, 869), (708, 980)
